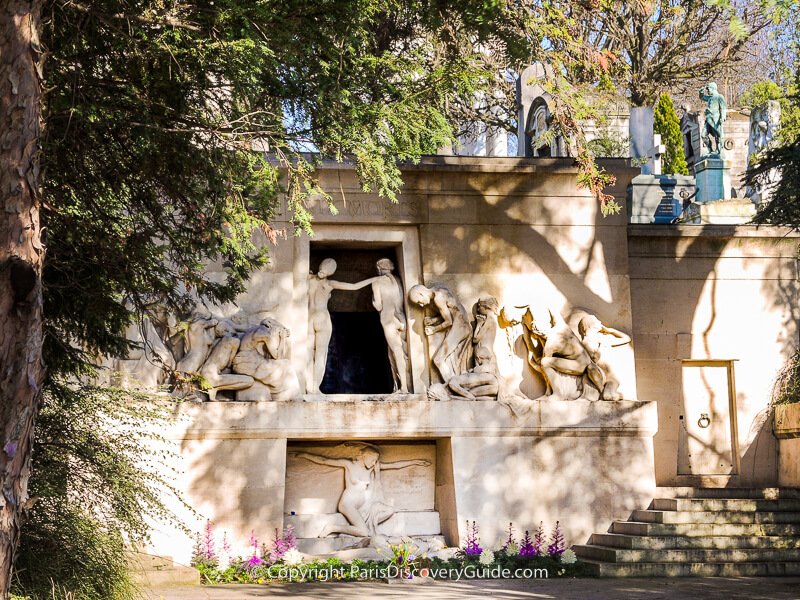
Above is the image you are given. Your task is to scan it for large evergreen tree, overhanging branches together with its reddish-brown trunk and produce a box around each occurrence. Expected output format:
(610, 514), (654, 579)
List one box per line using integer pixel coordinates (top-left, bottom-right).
(0, 0), (620, 589)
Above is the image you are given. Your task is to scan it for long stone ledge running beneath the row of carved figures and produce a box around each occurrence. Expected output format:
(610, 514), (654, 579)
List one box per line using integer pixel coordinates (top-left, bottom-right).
(166, 396), (658, 439)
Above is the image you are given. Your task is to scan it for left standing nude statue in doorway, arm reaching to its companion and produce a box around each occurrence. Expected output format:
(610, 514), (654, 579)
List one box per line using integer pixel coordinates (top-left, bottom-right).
(307, 258), (378, 394)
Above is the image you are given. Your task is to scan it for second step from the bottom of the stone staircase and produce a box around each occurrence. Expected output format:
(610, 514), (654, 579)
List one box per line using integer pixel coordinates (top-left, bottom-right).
(572, 545), (800, 563)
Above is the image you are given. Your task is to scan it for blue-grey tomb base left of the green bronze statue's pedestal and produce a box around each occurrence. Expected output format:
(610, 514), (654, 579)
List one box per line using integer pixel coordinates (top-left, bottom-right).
(627, 174), (695, 223)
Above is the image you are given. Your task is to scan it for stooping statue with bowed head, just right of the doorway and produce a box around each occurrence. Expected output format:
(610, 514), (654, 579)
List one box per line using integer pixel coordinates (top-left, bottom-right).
(408, 285), (472, 382)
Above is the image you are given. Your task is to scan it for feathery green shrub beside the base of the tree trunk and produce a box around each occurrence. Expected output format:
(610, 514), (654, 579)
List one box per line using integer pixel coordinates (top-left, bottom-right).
(13, 384), (183, 600)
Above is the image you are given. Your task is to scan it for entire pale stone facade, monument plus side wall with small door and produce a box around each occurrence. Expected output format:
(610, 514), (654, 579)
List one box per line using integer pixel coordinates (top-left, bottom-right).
(134, 157), (797, 561)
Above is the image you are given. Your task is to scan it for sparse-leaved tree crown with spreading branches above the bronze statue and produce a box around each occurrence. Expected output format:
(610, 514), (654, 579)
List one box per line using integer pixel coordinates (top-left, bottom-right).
(540, 0), (770, 106)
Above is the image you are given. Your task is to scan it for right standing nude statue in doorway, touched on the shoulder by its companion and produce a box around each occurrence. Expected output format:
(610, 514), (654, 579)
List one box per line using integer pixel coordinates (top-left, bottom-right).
(371, 258), (408, 393)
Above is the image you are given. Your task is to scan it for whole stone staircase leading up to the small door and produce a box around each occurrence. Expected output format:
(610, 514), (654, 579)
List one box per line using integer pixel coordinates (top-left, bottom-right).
(573, 488), (800, 577)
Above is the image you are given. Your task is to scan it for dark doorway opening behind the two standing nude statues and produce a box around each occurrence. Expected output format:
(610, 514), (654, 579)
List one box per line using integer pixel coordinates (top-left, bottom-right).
(310, 244), (402, 394)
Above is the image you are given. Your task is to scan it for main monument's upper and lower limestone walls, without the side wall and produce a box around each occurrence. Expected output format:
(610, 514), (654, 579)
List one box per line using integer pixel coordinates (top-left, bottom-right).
(145, 157), (656, 560)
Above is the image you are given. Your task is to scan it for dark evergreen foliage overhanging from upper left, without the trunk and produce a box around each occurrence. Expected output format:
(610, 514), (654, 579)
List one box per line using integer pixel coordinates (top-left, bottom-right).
(42, 0), (520, 372)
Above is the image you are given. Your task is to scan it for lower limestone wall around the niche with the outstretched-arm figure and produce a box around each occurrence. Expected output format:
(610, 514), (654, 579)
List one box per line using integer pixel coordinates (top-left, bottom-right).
(151, 397), (656, 562)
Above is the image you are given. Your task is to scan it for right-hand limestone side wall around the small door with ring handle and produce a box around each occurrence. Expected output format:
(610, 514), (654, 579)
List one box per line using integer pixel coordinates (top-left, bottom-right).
(629, 225), (798, 486)
